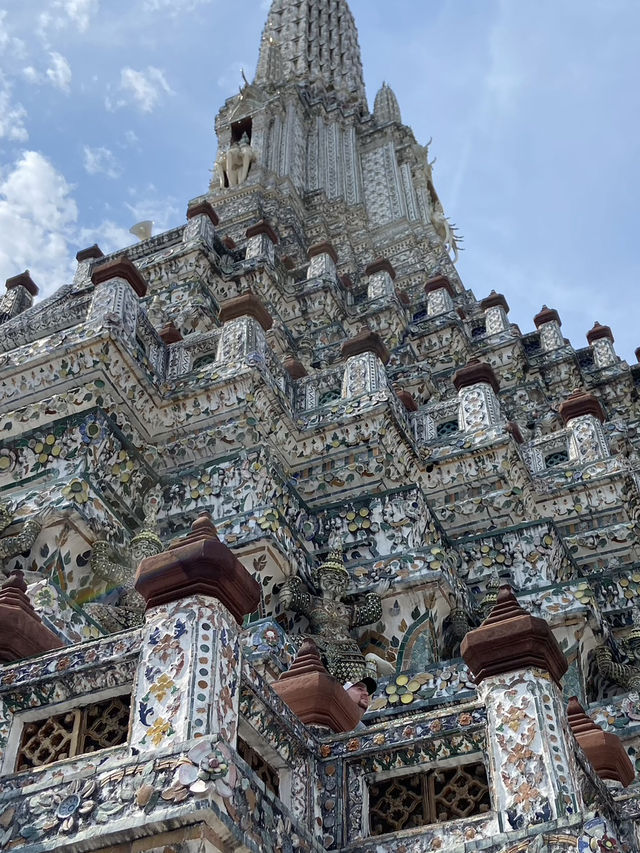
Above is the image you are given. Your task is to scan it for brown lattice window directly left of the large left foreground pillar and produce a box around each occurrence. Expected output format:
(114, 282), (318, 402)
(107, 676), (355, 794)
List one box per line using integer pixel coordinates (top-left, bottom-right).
(16, 694), (131, 770)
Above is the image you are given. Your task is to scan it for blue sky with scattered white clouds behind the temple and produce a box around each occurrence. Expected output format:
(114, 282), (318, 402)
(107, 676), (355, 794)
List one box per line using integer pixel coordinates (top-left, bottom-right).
(0, 0), (640, 361)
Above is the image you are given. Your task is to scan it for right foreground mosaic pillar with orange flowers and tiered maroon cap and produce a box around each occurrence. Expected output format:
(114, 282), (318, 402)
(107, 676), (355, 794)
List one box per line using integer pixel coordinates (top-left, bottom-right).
(460, 585), (584, 831)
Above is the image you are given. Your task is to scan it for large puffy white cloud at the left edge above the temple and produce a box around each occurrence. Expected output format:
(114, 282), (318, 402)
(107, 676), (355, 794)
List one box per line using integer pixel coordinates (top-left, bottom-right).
(0, 151), (78, 295)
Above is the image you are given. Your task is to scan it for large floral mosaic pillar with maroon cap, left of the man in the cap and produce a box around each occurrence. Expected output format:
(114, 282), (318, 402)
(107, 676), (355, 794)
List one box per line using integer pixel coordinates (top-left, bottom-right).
(131, 513), (260, 753)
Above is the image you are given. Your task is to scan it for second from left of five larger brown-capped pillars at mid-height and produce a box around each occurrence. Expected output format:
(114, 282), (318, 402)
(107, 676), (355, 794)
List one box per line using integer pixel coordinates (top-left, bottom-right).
(216, 293), (273, 364)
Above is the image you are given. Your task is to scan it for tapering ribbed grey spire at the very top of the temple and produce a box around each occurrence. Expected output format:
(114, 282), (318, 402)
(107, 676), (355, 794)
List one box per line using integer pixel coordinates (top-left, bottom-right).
(256, 0), (365, 102)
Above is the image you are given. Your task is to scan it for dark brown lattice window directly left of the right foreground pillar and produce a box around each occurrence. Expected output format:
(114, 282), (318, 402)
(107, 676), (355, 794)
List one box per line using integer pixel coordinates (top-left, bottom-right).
(369, 764), (491, 835)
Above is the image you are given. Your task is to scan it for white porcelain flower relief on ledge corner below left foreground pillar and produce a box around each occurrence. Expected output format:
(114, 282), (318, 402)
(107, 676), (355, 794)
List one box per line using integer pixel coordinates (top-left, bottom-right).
(161, 740), (237, 803)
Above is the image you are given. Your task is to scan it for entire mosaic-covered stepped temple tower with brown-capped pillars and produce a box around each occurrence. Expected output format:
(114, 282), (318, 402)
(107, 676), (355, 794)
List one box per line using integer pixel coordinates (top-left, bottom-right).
(0, 0), (640, 853)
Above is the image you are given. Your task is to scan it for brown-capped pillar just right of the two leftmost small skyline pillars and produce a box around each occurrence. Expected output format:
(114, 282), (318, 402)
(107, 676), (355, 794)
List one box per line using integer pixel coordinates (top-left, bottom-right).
(86, 257), (147, 344)
